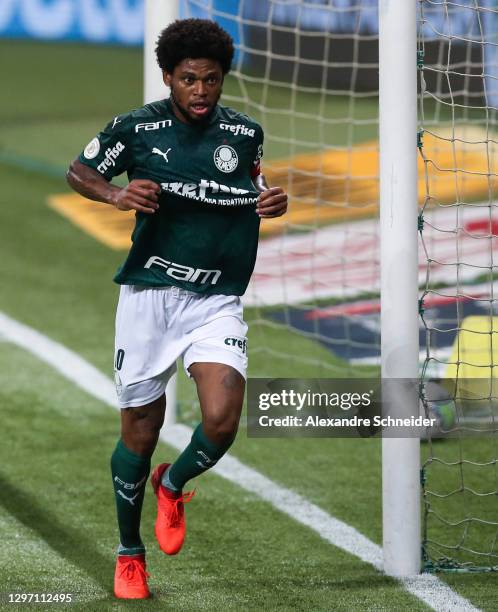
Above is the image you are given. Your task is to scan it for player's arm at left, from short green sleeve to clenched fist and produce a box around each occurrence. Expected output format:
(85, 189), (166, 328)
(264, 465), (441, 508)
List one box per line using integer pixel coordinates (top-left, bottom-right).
(66, 115), (161, 214)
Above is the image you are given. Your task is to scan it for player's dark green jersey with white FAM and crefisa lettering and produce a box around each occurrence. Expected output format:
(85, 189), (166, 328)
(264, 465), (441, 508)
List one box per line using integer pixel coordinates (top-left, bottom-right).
(79, 100), (263, 295)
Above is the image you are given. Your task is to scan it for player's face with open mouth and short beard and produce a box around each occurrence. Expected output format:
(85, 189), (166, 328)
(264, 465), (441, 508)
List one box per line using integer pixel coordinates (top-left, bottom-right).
(163, 58), (223, 123)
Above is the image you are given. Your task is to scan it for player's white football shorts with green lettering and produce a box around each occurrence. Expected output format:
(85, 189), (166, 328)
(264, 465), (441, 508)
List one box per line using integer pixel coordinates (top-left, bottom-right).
(114, 285), (247, 408)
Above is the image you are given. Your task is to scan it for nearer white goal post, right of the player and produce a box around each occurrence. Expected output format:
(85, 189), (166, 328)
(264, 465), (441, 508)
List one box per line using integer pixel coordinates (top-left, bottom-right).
(379, 0), (421, 576)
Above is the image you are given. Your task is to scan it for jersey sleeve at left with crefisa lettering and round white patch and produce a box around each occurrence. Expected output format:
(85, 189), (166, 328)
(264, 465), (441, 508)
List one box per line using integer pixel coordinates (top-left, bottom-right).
(78, 115), (131, 181)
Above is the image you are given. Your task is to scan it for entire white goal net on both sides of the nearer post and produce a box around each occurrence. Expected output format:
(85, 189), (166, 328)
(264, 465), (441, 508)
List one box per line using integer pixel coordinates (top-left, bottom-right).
(181, 0), (498, 570)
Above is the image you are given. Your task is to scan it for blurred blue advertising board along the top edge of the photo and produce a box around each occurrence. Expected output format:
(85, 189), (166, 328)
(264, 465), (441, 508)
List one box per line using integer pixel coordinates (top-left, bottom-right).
(0, 0), (498, 45)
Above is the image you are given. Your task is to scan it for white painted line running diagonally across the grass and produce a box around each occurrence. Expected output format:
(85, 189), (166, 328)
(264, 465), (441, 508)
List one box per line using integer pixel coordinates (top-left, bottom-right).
(0, 312), (479, 612)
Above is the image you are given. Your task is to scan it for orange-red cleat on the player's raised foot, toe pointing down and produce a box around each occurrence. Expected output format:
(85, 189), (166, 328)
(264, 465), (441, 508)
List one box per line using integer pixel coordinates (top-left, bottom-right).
(150, 463), (195, 555)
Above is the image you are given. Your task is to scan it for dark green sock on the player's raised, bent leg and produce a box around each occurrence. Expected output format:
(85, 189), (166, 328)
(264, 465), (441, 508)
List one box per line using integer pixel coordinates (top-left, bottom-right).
(163, 423), (234, 490)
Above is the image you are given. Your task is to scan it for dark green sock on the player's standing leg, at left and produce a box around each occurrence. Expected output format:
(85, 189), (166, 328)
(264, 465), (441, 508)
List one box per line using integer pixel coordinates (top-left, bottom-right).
(111, 440), (150, 555)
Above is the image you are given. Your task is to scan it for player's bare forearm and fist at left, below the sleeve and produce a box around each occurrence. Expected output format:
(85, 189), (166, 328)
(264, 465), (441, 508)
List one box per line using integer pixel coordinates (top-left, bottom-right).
(66, 158), (160, 214)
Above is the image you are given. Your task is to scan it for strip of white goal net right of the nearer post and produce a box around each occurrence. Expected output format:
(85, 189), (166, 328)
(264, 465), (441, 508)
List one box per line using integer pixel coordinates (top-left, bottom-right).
(418, 0), (498, 570)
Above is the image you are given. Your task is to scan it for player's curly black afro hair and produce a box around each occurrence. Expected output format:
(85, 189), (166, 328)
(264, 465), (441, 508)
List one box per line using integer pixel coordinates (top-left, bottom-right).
(156, 19), (234, 75)
